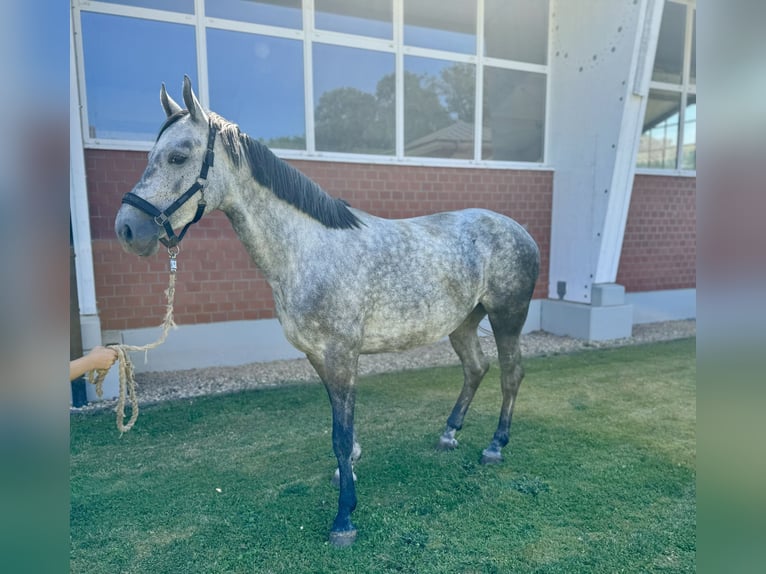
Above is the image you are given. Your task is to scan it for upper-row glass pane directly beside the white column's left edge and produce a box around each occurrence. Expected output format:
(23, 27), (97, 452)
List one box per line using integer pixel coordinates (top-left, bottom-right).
(484, 0), (548, 64)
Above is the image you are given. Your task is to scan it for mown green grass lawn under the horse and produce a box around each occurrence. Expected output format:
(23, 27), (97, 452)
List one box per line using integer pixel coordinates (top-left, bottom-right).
(70, 339), (696, 574)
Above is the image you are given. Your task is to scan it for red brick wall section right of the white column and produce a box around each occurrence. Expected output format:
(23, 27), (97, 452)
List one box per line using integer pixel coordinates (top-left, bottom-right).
(617, 175), (697, 291)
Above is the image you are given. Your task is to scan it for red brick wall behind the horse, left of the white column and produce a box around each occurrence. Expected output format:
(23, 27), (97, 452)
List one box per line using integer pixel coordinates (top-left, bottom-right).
(85, 150), (553, 329)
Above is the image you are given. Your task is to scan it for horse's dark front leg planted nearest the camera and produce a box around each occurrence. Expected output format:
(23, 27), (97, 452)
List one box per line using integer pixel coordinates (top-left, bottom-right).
(309, 352), (359, 548)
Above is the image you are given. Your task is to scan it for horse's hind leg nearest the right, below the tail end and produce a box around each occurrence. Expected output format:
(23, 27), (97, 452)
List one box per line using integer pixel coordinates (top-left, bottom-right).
(481, 311), (526, 464)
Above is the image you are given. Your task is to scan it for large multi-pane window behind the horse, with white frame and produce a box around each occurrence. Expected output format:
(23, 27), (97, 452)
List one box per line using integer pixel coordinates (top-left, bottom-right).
(73, 0), (552, 164)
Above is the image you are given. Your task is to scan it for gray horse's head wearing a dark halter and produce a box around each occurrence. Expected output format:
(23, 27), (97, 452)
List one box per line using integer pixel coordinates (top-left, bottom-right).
(115, 76), (225, 256)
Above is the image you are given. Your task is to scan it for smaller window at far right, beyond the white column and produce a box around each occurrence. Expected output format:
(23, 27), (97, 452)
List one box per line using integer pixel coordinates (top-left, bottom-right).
(636, 0), (697, 171)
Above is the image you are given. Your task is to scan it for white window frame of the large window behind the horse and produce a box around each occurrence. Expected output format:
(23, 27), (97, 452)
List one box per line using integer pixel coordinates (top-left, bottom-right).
(72, 0), (553, 170)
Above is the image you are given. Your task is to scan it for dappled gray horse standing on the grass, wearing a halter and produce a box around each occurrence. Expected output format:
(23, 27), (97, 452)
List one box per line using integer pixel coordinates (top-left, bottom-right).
(115, 77), (539, 546)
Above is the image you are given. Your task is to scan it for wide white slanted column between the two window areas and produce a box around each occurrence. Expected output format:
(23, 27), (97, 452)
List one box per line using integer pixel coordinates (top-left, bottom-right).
(548, 0), (663, 303)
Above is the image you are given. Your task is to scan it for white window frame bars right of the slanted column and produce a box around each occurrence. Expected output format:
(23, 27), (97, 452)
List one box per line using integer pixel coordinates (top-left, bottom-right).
(636, 0), (697, 177)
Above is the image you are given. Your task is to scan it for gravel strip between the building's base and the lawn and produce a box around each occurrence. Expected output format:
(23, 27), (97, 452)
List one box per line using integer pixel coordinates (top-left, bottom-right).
(70, 319), (697, 412)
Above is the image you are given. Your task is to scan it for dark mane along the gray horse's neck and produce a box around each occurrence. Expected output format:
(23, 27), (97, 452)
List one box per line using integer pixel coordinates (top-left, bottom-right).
(208, 112), (362, 229)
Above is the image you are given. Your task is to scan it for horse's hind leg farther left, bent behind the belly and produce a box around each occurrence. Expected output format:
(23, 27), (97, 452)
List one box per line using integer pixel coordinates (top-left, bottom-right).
(439, 305), (489, 450)
